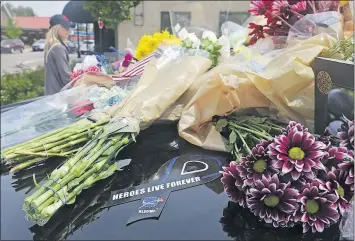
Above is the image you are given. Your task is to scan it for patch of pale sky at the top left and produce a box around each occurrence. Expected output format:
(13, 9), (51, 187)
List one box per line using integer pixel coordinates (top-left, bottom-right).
(6, 1), (69, 17)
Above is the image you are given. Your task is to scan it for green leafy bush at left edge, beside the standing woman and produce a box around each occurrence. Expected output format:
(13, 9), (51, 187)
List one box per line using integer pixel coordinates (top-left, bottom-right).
(1, 67), (45, 106)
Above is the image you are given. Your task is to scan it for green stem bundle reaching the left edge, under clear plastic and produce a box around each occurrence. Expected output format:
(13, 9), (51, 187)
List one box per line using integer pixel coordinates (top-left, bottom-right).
(1, 119), (108, 172)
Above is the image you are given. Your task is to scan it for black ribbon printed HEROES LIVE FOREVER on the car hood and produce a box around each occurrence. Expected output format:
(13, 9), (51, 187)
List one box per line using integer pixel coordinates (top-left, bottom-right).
(107, 154), (226, 225)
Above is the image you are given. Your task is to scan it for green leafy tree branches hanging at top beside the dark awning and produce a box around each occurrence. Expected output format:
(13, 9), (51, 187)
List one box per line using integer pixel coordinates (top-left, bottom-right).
(84, 1), (141, 29)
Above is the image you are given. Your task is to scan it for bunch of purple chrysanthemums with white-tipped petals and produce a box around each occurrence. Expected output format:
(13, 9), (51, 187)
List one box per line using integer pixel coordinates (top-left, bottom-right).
(221, 121), (354, 233)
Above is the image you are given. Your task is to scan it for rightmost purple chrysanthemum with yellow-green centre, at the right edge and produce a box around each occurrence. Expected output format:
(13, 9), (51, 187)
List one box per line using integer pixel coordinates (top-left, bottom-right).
(319, 167), (353, 214)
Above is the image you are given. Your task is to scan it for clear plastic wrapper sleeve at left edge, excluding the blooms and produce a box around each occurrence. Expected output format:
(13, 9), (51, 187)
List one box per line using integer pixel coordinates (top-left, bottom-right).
(1, 86), (94, 149)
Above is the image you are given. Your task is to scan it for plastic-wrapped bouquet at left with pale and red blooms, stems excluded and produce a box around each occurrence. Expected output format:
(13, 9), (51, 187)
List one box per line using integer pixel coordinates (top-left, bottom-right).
(1, 85), (128, 149)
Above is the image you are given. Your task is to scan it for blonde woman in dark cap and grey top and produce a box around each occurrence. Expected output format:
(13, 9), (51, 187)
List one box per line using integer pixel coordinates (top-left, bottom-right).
(44, 14), (71, 95)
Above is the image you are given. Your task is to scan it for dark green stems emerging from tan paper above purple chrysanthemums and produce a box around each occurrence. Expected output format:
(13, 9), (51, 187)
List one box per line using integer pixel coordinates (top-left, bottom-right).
(213, 114), (283, 161)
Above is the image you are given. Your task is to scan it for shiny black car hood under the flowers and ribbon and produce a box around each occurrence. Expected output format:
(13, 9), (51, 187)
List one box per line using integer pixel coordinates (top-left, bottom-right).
(1, 124), (339, 241)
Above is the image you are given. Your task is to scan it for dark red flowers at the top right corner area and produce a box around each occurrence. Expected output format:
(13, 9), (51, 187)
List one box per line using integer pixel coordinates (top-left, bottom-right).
(249, 0), (342, 45)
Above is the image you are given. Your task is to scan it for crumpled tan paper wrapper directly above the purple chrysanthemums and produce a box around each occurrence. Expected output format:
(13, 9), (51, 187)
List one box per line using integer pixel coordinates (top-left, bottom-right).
(178, 33), (336, 151)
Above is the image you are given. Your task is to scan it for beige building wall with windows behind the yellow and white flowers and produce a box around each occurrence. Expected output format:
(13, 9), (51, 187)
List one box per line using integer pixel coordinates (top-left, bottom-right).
(116, 1), (250, 49)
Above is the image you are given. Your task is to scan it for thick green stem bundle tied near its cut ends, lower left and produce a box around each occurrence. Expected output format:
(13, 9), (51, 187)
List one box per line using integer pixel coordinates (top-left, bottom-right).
(24, 119), (134, 226)
